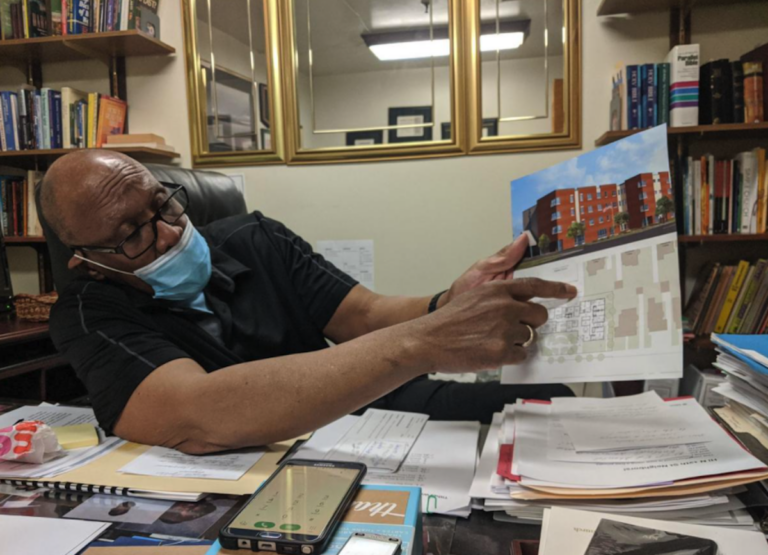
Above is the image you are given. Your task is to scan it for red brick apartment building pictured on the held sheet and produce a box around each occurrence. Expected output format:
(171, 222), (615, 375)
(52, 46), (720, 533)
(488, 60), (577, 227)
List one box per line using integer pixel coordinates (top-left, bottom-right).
(523, 172), (673, 251)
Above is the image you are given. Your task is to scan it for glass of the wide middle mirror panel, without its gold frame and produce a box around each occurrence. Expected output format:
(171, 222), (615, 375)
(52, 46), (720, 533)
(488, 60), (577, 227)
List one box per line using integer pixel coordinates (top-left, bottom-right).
(293, 0), (452, 150)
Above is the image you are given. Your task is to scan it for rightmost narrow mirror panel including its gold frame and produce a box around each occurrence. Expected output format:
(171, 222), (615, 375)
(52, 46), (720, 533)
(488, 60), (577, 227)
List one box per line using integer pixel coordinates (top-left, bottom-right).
(463, 0), (581, 154)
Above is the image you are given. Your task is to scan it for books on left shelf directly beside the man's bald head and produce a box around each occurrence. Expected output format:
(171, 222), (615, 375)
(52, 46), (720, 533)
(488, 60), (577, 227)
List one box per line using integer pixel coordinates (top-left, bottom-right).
(0, 170), (43, 237)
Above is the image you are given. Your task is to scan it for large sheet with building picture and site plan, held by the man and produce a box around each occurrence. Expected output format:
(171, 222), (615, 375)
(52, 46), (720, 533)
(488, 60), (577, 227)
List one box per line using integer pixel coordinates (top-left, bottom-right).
(510, 126), (683, 383)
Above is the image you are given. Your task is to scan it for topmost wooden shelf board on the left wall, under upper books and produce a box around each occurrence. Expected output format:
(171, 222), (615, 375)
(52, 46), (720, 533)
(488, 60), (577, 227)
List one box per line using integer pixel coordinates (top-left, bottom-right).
(0, 30), (176, 63)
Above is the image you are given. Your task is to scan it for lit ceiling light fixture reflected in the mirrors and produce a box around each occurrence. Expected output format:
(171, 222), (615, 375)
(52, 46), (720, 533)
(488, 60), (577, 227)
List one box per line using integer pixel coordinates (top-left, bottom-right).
(361, 19), (531, 62)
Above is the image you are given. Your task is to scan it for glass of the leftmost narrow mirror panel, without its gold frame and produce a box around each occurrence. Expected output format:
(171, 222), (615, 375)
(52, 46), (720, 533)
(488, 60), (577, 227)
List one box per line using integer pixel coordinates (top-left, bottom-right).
(193, 0), (273, 153)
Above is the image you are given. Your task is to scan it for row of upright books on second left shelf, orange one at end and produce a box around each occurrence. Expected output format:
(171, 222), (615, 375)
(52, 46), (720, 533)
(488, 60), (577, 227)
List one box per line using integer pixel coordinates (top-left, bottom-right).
(0, 87), (128, 151)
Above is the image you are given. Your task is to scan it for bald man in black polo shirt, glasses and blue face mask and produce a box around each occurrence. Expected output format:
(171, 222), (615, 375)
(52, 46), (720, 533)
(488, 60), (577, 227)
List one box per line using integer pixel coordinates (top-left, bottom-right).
(41, 150), (576, 453)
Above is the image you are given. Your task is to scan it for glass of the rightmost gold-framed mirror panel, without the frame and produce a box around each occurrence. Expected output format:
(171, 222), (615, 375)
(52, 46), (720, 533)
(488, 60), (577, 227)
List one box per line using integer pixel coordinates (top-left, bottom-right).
(480, 0), (568, 138)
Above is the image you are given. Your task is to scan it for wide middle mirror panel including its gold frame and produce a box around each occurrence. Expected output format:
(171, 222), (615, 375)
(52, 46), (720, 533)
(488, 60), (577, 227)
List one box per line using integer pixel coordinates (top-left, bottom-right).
(280, 0), (466, 164)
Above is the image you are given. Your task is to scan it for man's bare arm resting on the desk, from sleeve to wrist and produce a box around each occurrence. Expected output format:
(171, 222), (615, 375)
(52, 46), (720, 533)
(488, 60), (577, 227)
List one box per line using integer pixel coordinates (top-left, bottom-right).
(115, 320), (431, 453)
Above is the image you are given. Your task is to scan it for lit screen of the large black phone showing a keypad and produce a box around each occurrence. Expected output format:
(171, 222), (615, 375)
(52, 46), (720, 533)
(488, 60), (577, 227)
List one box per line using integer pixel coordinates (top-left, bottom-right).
(230, 465), (359, 536)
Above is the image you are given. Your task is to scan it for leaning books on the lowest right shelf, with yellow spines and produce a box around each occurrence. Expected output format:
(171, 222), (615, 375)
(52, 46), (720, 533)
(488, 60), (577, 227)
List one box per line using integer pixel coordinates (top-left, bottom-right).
(683, 259), (768, 336)
